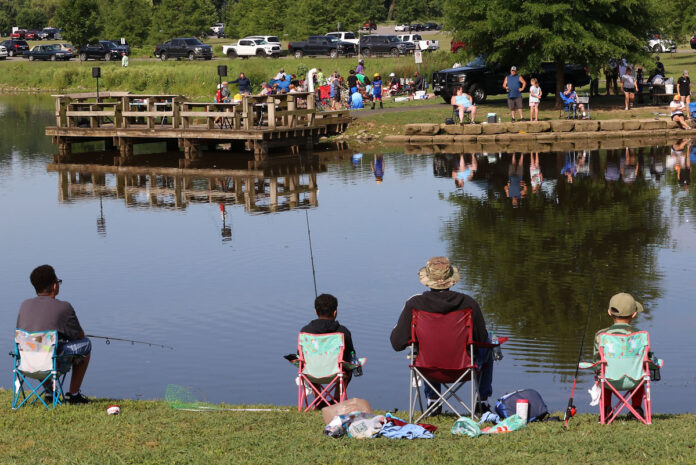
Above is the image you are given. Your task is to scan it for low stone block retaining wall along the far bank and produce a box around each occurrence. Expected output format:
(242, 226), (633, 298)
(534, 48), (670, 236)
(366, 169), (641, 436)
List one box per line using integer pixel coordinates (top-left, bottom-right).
(384, 119), (696, 146)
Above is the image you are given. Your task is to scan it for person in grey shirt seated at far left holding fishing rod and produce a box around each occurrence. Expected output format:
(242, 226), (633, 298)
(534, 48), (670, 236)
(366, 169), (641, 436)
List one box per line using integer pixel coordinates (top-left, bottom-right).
(17, 265), (92, 404)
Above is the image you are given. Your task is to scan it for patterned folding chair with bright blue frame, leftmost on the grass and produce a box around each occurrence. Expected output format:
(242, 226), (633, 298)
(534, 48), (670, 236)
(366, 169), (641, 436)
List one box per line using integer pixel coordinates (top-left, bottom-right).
(11, 329), (72, 409)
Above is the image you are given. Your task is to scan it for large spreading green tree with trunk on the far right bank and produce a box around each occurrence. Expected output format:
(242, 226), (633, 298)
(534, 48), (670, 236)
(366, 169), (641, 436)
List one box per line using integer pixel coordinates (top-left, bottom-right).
(444, 0), (665, 106)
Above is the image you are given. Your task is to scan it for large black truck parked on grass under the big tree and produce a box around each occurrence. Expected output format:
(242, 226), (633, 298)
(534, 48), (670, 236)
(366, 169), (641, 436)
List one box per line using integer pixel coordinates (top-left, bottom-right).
(432, 57), (590, 103)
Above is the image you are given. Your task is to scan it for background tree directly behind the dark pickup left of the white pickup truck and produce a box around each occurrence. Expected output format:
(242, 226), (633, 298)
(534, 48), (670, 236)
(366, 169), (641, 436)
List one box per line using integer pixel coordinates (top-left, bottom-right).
(152, 0), (217, 42)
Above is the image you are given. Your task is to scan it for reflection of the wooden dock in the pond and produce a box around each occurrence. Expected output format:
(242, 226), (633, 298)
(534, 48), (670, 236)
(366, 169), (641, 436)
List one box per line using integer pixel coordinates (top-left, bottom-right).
(47, 155), (326, 213)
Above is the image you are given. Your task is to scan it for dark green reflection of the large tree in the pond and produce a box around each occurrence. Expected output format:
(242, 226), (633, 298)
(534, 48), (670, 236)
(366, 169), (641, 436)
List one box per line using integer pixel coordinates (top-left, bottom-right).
(443, 165), (668, 372)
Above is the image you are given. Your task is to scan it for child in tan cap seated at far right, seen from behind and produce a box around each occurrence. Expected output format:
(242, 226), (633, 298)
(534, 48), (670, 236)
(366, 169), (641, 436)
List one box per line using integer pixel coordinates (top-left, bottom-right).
(593, 292), (644, 416)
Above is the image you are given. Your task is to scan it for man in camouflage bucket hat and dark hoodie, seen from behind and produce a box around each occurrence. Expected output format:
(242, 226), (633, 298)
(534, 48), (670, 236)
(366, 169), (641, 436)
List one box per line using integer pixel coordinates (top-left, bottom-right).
(390, 257), (493, 414)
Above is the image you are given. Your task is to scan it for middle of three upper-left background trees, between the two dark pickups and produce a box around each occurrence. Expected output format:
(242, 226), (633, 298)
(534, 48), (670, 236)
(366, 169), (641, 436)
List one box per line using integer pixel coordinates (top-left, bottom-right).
(101, 0), (152, 46)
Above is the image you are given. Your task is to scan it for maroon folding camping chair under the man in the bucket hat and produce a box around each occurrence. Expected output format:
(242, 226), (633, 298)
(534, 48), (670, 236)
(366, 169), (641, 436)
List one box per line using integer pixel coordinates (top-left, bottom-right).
(408, 309), (507, 423)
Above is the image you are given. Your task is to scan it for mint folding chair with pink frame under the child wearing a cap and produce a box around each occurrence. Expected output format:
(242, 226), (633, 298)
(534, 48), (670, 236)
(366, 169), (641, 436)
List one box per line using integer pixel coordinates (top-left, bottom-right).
(580, 331), (663, 425)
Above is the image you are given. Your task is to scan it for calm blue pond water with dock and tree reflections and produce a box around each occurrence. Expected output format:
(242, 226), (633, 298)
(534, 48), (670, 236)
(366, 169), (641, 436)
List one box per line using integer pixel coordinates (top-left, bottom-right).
(0, 96), (696, 412)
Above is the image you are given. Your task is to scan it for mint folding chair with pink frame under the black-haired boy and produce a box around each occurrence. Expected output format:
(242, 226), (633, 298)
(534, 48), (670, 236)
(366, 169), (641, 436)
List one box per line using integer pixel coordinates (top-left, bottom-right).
(297, 333), (346, 412)
